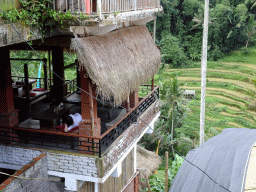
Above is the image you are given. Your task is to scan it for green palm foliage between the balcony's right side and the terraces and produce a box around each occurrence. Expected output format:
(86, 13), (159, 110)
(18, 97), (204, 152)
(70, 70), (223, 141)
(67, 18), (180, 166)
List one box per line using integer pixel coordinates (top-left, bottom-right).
(141, 76), (187, 154)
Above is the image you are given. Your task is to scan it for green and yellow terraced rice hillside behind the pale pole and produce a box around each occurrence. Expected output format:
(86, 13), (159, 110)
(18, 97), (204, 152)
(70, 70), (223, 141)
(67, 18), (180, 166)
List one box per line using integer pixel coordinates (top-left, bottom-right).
(164, 62), (256, 138)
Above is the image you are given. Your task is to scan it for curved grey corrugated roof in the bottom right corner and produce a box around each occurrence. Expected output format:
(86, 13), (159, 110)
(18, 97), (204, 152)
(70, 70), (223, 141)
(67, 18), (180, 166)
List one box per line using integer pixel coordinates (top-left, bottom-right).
(169, 128), (256, 192)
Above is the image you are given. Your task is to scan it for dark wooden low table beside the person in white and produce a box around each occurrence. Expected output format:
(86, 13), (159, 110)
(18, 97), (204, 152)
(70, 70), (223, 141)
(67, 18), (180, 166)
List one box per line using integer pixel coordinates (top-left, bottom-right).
(31, 103), (76, 130)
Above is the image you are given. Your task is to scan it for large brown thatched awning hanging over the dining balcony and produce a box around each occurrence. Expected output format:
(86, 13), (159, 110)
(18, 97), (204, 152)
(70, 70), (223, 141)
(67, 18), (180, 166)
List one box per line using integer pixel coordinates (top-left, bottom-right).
(71, 26), (161, 105)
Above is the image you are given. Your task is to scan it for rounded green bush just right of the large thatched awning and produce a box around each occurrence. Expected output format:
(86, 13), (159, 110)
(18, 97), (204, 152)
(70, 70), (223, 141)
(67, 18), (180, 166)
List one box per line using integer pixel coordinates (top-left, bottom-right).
(160, 34), (189, 68)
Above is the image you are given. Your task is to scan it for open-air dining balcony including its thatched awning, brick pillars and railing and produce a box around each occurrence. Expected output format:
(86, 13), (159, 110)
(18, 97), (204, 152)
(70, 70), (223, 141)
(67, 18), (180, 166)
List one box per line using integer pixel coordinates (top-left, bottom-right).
(0, 26), (161, 160)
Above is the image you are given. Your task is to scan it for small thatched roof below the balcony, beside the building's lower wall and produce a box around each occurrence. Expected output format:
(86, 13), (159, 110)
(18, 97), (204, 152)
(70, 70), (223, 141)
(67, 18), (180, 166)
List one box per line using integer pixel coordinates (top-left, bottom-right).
(136, 145), (162, 188)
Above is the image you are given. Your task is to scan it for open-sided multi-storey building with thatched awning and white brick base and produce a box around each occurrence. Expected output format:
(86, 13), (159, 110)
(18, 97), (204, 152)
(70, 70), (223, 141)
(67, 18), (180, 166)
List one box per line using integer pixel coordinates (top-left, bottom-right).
(0, 0), (163, 192)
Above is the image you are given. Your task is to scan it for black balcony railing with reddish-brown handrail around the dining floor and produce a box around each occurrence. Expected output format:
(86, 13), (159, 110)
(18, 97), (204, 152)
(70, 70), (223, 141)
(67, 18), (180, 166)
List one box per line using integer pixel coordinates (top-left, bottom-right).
(0, 85), (159, 157)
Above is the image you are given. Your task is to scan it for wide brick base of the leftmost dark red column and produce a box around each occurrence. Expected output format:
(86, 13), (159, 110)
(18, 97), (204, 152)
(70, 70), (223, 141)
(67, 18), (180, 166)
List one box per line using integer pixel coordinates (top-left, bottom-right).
(0, 110), (19, 127)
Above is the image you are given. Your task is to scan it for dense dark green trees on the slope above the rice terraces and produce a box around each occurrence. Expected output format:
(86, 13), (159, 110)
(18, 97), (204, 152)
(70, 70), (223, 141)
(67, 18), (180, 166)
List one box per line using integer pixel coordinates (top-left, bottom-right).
(156, 0), (256, 61)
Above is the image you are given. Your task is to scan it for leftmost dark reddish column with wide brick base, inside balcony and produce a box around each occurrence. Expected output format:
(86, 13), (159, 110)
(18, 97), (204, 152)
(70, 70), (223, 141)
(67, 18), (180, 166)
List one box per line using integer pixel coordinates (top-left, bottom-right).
(0, 47), (19, 126)
